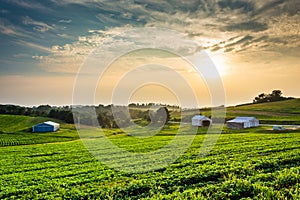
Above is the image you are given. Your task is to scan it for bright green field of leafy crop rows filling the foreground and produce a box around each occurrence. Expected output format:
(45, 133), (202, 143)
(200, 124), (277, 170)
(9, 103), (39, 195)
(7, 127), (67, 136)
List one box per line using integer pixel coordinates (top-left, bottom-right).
(0, 100), (300, 199)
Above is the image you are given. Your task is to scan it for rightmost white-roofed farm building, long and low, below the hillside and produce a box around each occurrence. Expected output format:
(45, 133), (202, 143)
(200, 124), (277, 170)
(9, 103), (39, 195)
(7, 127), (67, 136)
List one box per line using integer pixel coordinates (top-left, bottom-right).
(226, 117), (259, 129)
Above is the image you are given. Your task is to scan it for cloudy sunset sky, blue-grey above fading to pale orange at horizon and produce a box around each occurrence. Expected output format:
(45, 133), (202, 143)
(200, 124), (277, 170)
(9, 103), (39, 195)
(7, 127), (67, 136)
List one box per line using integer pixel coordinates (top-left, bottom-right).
(0, 0), (300, 106)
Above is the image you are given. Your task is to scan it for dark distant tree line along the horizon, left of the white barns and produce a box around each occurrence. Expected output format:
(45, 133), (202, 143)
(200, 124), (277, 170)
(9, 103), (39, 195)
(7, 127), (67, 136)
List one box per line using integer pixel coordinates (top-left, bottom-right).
(0, 103), (180, 128)
